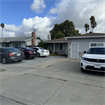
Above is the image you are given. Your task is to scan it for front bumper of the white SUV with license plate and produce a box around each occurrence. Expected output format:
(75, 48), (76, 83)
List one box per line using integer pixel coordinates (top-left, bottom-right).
(80, 60), (105, 72)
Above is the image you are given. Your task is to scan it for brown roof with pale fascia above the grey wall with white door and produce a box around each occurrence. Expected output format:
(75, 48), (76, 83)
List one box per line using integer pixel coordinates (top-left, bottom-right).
(65, 33), (105, 39)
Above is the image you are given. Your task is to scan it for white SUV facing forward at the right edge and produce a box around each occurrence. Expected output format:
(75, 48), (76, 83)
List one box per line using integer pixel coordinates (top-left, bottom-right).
(80, 47), (105, 72)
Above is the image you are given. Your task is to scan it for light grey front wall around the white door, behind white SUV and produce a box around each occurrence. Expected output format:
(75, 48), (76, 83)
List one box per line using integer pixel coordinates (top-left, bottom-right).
(68, 38), (105, 58)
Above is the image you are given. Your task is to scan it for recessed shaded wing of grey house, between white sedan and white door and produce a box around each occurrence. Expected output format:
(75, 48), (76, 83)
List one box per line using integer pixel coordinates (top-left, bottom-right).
(44, 38), (68, 54)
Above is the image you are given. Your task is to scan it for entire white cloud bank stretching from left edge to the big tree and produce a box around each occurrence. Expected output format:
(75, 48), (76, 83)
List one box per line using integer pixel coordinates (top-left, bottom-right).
(0, 16), (52, 40)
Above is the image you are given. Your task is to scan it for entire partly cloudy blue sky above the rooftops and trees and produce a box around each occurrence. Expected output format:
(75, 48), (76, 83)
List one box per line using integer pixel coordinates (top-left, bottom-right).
(0, 0), (105, 40)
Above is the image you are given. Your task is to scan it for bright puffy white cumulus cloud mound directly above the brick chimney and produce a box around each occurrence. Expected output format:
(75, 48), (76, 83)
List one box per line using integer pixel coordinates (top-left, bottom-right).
(21, 16), (52, 39)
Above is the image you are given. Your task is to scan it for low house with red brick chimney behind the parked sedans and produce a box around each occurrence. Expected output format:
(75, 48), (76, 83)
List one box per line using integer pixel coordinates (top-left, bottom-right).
(0, 32), (42, 47)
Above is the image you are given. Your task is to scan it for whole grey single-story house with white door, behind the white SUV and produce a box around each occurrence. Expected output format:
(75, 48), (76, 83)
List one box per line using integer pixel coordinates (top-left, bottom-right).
(45, 33), (105, 59)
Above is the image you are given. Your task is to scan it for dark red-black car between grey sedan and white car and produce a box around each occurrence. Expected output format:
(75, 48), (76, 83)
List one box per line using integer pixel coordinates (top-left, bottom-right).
(17, 47), (38, 59)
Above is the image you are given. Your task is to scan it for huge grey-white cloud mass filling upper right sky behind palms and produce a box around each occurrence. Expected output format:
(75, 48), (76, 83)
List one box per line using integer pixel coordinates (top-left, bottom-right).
(49, 0), (105, 33)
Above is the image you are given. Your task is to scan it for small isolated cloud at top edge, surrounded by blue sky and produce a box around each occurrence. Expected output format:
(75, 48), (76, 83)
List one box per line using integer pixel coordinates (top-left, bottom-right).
(31, 0), (46, 13)
